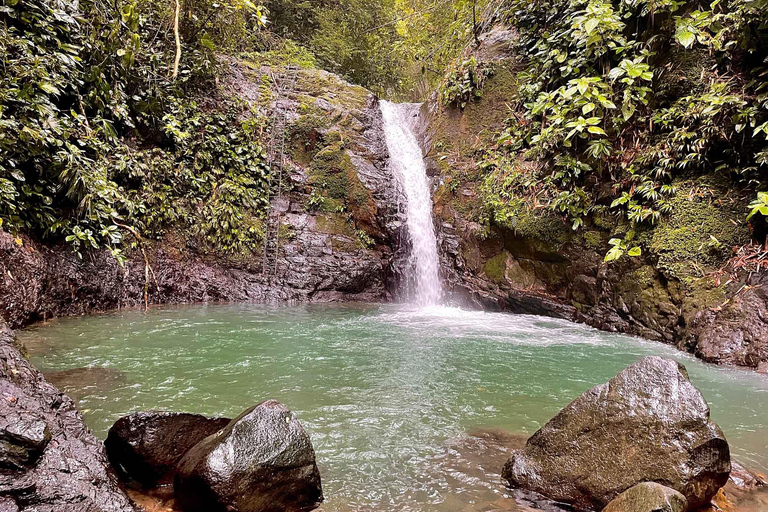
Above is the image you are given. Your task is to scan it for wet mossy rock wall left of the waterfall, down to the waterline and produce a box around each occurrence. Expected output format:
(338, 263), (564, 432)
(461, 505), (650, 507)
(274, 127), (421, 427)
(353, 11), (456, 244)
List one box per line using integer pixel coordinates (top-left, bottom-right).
(0, 60), (403, 329)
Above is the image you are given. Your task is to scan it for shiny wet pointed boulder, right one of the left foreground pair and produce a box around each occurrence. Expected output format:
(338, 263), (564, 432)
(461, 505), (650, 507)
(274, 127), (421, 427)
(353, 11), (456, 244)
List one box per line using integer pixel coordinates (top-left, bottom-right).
(174, 400), (323, 512)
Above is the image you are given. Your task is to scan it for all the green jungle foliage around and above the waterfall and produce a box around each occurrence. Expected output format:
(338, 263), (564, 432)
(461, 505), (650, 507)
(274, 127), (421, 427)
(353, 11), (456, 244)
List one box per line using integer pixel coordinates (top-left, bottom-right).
(0, 0), (768, 259)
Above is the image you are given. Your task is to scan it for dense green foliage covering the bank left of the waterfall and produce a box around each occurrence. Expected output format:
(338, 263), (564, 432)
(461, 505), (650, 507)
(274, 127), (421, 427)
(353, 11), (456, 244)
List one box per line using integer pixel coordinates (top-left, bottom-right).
(0, 0), (268, 261)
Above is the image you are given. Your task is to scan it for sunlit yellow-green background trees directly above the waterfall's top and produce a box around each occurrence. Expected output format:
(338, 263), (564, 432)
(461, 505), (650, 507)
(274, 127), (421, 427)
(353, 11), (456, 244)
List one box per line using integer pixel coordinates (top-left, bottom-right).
(264, 0), (492, 97)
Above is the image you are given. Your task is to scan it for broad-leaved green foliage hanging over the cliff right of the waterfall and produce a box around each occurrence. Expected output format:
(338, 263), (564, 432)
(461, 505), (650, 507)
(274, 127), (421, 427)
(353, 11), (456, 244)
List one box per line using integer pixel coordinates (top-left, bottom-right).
(483, 0), (768, 260)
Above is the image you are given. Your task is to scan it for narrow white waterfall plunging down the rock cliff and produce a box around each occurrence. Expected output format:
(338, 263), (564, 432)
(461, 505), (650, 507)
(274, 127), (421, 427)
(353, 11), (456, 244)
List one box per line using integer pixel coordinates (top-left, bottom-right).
(381, 101), (442, 306)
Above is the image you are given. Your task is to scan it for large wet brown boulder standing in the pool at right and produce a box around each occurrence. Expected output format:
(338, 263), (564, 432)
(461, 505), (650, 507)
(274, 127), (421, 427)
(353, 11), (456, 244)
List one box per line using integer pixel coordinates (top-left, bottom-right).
(502, 357), (731, 510)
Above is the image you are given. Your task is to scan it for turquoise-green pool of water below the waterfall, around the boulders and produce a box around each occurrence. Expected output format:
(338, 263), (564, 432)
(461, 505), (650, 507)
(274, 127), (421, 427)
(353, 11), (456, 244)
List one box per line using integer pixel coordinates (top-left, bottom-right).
(21, 305), (768, 512)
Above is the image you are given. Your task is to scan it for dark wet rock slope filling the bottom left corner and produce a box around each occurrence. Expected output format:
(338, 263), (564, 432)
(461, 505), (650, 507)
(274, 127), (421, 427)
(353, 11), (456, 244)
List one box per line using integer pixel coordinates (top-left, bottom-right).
(0, 320), (134, 512)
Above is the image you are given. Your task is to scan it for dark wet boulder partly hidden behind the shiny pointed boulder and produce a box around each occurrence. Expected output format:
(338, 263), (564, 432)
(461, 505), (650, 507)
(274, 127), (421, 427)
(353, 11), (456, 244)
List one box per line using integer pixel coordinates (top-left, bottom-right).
(104, 412), (231, 488)
